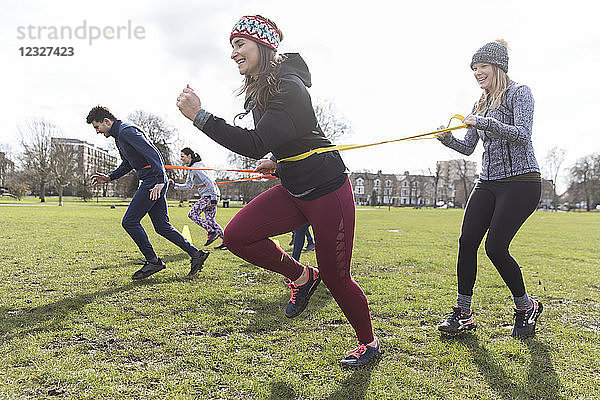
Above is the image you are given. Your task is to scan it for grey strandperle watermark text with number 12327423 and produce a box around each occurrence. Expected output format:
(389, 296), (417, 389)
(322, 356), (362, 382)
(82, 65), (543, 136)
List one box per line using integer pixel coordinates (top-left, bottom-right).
(16, 19), (146, 57)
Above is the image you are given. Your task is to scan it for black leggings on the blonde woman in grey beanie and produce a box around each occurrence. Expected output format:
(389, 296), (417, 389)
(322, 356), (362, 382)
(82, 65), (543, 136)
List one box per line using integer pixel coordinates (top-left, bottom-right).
(457, 181), (542, 297)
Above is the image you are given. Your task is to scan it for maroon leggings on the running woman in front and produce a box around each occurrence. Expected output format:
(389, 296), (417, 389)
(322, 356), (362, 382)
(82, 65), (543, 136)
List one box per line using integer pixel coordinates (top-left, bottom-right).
(223, 180), (374, 343)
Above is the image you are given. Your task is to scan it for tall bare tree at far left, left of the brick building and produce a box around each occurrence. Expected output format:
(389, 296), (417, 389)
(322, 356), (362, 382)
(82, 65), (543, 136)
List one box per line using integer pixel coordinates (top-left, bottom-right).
(17, 119), (60, 203)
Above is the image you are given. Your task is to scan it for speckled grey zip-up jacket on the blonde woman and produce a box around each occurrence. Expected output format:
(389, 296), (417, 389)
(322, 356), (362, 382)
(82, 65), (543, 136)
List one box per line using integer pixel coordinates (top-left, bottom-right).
(440, 81), (540, 180)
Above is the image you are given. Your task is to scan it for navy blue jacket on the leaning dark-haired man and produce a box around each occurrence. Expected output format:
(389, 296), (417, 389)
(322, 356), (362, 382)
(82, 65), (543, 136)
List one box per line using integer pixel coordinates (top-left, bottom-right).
(109, 119), (168, 187)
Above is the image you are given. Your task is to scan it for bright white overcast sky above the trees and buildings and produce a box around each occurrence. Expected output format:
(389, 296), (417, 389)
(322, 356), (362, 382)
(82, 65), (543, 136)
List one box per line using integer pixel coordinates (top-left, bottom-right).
(0, 0), (600, 191)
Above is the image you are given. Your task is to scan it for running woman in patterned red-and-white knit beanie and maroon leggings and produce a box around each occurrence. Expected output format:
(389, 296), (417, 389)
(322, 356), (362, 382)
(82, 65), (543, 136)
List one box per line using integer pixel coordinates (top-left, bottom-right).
(177, 15), (382, 367)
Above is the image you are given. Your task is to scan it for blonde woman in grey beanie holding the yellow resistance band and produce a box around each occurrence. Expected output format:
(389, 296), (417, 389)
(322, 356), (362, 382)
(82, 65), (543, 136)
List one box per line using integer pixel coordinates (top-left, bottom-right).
(437, 40), (542, 338)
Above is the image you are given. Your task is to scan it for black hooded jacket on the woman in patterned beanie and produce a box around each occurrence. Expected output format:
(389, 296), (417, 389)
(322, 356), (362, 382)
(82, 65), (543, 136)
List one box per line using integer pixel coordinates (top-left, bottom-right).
(194, 53), (347, 200)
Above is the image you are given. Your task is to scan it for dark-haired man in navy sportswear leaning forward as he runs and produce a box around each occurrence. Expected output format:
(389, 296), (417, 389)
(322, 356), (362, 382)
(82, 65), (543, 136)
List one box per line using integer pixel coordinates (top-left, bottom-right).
(86, 106), (209, 279)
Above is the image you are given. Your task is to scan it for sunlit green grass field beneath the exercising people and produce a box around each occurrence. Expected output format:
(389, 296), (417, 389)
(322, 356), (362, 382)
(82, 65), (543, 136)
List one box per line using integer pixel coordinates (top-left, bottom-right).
(0, 201), (600, 400)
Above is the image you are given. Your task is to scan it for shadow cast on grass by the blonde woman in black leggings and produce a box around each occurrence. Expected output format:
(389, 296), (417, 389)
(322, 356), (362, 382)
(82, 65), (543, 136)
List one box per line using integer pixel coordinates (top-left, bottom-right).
(441, 334), (564, 400)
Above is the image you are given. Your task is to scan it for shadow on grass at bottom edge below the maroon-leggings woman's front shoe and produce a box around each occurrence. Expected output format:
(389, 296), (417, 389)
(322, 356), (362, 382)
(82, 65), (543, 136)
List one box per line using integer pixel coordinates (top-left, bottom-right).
(269, 358), (381, 400)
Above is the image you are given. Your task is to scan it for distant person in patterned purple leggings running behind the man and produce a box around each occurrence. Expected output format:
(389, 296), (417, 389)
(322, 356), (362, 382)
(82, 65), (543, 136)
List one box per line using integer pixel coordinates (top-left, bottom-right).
(171, 147), (223, 246)
